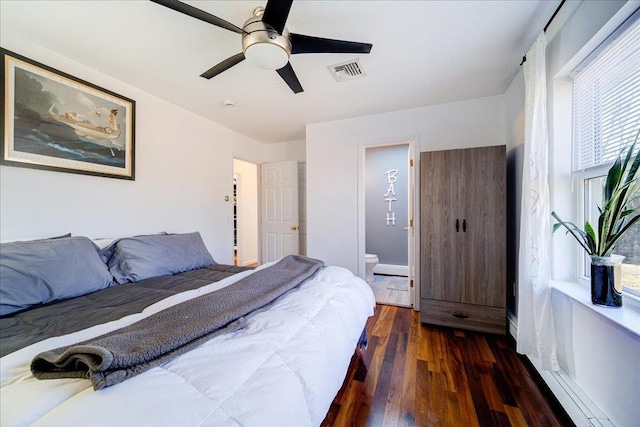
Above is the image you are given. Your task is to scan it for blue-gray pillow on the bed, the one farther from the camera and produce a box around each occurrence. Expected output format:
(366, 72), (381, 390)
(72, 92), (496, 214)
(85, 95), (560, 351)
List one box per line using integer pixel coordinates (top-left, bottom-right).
(100, 232), (215, 284)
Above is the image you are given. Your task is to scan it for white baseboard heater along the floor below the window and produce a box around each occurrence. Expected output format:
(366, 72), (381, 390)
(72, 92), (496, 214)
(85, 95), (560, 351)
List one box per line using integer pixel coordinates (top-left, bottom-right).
(507, 312), (614, 427)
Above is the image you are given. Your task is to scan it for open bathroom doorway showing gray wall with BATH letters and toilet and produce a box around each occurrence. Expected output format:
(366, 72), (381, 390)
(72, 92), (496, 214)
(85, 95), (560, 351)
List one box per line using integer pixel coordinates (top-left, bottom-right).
(360, 142), (414, 307)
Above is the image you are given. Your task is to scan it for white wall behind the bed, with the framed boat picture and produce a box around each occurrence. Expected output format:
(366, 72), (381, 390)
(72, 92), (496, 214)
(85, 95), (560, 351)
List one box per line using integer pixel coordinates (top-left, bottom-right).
(0, 32), (264, 264)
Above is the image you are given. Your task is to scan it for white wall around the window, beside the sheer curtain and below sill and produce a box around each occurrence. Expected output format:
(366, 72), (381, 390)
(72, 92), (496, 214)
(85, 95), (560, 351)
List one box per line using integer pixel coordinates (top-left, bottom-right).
(505, 1), (640, 426)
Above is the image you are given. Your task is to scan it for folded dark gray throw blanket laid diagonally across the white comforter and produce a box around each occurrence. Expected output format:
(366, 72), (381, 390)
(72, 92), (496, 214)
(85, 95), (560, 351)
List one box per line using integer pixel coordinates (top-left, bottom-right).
(31, 256), (324, 390)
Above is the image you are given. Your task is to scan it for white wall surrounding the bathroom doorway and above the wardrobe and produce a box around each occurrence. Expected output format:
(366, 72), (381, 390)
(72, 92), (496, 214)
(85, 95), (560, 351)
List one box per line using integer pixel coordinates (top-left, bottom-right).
(307, 96), (505, 274)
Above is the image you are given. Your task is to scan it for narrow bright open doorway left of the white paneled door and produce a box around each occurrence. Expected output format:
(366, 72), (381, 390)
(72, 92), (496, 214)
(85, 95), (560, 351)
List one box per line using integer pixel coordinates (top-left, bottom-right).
(233, 158), (260, 267)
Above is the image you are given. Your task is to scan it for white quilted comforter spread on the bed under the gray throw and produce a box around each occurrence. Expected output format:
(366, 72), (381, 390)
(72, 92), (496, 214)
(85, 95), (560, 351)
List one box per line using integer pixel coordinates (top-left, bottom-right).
(0, 266), (375, 427)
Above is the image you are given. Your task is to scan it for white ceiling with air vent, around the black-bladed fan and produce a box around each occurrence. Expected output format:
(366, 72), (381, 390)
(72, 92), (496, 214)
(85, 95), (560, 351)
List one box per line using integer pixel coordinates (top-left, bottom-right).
(0, 0), (559, 143)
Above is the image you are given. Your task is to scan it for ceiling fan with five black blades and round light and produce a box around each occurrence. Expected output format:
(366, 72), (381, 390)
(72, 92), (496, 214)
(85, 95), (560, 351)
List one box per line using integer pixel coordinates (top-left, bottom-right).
(151, 0), (373, 93)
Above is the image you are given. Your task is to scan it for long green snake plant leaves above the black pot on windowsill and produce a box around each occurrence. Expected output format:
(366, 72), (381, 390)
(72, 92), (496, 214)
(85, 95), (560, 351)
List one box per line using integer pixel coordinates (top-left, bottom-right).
(551, 132), (640, 257)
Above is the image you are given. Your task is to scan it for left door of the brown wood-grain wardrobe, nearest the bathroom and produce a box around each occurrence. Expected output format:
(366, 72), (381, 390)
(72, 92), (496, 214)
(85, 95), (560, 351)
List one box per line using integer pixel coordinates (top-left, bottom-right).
(420, 150), (462, 301)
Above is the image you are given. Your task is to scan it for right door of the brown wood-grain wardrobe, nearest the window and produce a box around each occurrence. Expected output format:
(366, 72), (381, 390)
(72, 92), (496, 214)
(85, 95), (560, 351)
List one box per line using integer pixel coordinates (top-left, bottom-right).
(460, 146), (506, 307)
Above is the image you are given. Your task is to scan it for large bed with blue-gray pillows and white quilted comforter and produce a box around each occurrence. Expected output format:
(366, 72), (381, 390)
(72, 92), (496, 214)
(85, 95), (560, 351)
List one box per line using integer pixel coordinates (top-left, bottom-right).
(0, 233), (375, 426)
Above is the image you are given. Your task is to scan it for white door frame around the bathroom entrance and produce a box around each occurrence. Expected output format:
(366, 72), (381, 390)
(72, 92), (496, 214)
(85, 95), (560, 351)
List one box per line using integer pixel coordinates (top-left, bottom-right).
(357, 135), (420, 310)
